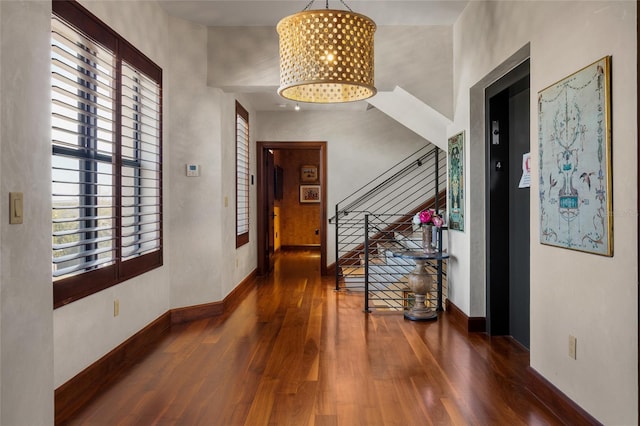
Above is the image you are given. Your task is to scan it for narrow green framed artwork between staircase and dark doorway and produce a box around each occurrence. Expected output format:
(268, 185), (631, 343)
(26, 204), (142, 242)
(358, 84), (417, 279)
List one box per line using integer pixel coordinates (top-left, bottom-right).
(448, 132), (464, 232)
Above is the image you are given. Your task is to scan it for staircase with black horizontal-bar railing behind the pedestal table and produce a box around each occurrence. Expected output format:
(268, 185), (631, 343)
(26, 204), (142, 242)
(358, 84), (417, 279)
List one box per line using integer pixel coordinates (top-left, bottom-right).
(330, 145), (446, 311)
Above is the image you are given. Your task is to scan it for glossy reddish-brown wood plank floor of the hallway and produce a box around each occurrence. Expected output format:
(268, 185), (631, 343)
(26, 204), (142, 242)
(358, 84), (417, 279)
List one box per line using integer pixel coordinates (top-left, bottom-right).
(65, 253), (560, 426)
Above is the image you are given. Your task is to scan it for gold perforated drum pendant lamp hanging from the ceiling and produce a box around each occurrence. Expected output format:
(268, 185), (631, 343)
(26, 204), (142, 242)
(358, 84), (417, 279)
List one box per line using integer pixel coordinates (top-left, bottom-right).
(277, 0), (376, 103)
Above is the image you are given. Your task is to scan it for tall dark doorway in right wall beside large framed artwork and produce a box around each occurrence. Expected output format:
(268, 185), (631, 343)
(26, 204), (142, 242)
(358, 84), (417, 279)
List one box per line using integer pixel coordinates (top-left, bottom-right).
(485, 60), (530, 349)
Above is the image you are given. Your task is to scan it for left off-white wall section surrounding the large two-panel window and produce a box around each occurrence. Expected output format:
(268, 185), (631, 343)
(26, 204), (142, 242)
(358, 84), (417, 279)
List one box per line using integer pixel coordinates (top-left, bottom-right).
(53, 1), (177, 387)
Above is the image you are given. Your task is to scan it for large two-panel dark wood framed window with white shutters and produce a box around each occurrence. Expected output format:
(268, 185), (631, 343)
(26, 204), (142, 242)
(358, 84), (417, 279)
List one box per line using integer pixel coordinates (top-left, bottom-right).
(51, 1), (162, 307)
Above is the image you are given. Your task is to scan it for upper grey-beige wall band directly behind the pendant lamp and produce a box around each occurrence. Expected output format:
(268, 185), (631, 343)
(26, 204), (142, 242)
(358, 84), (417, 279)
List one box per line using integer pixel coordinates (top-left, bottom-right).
(208, 25), (453, 117)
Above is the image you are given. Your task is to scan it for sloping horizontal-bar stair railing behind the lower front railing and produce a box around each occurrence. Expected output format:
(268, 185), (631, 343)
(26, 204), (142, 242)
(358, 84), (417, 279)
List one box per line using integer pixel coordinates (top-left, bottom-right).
(329, 144), (447, 291)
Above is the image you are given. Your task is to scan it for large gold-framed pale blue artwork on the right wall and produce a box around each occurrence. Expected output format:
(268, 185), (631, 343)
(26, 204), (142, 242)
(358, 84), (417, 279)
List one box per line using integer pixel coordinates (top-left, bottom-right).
(538, 56), (613, 256)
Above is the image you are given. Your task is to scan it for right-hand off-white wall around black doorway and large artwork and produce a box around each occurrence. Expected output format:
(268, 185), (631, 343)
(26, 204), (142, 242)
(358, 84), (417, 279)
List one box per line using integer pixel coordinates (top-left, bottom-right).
(449, 1), (638, 425)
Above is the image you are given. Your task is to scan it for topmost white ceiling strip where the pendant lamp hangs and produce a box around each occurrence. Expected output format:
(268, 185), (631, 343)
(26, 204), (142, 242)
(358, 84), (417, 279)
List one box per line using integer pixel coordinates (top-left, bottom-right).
(159, 0), (468, 27)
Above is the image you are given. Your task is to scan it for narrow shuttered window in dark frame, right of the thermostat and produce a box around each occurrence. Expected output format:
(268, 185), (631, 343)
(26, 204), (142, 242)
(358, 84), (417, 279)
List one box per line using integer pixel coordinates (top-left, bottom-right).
(236, 102), (249, 248)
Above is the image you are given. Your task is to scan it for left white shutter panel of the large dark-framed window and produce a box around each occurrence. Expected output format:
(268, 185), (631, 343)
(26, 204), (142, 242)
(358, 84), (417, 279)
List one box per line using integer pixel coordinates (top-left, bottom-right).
(51, 17), (116, 279)
